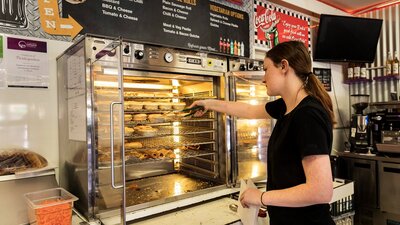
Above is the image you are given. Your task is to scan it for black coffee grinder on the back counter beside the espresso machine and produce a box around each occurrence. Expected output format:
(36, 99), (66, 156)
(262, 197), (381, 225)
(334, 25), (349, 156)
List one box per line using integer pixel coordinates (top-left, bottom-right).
(349, 94), (370, 153)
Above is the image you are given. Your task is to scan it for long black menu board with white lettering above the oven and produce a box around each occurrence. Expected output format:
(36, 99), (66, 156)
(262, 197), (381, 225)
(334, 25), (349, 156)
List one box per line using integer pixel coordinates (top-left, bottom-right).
(62, 0), (250, 57)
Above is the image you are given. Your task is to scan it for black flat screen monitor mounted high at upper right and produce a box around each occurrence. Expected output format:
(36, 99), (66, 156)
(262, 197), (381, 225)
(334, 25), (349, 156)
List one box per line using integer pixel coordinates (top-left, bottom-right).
(313, 14), (382, 63)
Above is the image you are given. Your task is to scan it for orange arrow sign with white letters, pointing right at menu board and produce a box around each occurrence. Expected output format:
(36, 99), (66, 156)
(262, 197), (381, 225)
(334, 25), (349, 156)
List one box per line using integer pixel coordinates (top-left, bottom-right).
(38, 0), (82, 38)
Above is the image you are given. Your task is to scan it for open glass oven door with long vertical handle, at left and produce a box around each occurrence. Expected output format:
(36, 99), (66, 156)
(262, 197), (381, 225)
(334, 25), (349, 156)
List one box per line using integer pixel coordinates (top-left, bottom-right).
(90, 41), (126, 224)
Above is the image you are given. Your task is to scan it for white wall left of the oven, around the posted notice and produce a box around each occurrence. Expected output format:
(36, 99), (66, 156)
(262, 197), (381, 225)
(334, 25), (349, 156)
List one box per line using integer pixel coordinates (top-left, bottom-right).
(0, 34), (71, 166)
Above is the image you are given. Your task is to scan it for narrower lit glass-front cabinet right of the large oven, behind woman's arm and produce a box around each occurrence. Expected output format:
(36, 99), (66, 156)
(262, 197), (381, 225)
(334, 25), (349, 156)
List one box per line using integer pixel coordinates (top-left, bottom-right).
(226, 60), (275, 184)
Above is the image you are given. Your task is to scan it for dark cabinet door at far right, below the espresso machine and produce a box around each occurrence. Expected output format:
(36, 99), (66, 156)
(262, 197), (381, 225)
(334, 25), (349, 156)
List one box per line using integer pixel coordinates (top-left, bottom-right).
(379, 162), (400, 214)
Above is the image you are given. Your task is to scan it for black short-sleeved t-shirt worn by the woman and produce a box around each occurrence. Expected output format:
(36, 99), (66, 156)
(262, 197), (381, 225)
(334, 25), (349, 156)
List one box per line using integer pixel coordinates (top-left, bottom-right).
(265, 96), (335, 225)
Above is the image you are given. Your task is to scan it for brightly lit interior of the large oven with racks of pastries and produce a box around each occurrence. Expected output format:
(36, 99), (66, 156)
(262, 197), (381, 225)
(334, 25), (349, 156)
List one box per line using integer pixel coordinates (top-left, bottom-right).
(98, 69), (225, 211)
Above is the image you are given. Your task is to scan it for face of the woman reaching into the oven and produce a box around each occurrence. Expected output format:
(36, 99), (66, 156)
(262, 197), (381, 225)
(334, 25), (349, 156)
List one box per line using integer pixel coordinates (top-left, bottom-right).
(264, 58), (282, 96)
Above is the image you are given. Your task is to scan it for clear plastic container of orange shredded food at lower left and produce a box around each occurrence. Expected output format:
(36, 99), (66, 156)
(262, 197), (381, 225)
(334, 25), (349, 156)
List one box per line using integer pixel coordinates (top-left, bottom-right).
(24, 188), (78, 225)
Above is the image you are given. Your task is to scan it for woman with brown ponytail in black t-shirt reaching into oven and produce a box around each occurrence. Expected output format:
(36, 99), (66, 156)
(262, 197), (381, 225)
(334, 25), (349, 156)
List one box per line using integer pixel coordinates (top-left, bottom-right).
(192, 41), (335, 225)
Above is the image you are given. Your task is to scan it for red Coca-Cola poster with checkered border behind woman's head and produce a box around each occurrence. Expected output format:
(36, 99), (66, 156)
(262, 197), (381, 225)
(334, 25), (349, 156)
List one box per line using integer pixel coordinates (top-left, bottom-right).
(254, 0), (311, 49)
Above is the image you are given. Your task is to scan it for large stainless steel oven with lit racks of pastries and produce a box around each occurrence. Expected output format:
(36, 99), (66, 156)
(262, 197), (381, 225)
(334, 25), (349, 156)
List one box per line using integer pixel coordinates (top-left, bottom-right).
(57, 36), (269, 224)
